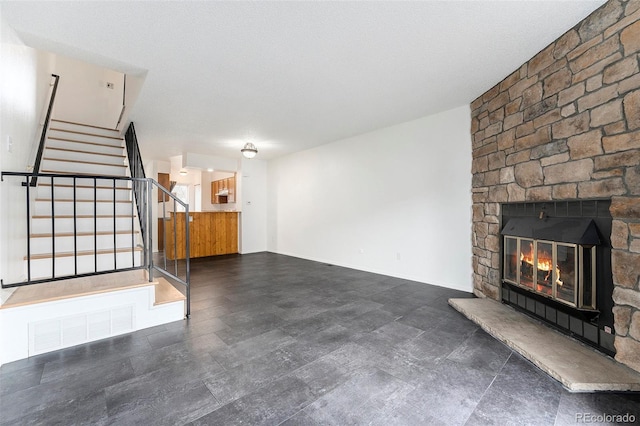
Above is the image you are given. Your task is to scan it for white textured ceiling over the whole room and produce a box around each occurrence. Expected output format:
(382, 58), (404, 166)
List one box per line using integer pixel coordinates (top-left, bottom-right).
(0, 0), (604, 159)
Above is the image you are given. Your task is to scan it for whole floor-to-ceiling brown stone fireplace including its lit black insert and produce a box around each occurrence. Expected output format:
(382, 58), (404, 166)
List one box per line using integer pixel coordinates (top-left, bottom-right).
(471, 0), (640, 371)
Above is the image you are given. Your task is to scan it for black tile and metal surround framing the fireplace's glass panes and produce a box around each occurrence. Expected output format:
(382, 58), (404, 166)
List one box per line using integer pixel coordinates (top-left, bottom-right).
(500, 200), (615, 356)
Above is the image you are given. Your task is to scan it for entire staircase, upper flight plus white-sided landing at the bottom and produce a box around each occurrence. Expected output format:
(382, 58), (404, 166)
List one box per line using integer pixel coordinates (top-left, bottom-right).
(0, 119), (189, 365)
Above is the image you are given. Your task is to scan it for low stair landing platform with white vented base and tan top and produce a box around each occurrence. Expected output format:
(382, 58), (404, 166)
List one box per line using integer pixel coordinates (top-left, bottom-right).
(0, 269), (185, 365)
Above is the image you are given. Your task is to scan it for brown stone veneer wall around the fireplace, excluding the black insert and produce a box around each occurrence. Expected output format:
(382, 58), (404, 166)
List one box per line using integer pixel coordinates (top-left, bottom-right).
(471, 0), (640, 371)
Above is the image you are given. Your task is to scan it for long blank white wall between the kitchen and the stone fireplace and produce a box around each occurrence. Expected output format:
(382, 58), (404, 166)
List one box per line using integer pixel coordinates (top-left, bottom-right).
(268, 106), (472, 291)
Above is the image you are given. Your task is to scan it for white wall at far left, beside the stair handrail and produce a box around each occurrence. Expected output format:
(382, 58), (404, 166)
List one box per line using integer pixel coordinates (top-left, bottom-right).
(0, 21), (51, 284)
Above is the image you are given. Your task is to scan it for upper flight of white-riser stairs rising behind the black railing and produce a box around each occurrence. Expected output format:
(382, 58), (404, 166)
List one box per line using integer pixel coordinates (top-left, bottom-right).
(30, 119), (142, 280)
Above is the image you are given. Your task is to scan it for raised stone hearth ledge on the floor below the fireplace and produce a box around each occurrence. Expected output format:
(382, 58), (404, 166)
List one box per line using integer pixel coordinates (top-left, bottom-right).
(449, 299), (640, 392)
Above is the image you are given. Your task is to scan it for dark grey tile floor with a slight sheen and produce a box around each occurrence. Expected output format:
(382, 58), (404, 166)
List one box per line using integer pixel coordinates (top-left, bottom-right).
(0, 253), (640, 425)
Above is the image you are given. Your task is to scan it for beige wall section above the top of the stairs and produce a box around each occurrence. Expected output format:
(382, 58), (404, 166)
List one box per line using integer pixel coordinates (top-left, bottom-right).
(52, 55), (124, 129)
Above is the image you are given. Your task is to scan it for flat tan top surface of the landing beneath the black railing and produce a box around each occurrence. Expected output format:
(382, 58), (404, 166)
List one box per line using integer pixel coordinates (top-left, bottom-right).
(0, 270), (156, 309)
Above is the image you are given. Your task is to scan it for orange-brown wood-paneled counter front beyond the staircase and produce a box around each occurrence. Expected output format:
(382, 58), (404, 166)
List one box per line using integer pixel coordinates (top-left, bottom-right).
(165, 212), (238, 260)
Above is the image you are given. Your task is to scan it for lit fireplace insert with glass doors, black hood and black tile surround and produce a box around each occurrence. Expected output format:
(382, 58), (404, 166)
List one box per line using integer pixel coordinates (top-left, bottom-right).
(501, 200), (615, 355)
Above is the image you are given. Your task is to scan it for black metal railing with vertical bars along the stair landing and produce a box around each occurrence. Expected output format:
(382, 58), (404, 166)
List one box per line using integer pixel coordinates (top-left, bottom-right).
(0, 172), (191, 317)
